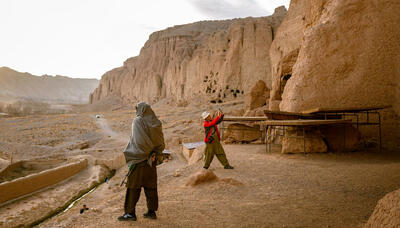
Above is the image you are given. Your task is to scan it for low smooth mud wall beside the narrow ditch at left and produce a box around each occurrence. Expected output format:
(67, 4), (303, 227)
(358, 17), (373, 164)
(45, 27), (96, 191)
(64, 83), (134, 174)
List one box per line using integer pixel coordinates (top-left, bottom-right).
(0, 160), (87, 204)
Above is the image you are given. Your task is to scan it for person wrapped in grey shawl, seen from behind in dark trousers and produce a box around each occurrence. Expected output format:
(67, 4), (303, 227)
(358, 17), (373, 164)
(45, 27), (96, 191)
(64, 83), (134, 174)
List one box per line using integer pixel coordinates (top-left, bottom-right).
(118, 102), (165, 221)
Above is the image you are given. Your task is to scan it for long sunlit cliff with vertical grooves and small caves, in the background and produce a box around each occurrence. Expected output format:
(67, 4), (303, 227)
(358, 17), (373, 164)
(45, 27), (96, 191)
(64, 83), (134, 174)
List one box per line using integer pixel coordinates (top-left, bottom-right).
(90, 7), (286, 103)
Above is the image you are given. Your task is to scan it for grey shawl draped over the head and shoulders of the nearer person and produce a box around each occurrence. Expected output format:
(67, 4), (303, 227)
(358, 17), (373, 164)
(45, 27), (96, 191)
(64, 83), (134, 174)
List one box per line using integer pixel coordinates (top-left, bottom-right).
(124, 102), (165, 164)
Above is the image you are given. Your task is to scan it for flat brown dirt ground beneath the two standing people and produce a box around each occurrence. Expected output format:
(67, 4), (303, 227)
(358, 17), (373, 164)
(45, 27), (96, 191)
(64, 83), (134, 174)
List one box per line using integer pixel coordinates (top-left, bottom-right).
(42, 145), (400, 227)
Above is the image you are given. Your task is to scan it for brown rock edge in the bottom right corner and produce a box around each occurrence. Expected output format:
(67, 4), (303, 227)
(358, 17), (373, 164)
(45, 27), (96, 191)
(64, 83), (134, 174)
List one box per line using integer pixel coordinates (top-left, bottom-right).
(365, 189), (400, 228)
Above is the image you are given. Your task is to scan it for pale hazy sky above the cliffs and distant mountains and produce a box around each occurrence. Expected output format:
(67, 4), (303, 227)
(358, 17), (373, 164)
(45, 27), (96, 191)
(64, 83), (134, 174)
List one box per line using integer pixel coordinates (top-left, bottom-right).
(0, 0), (289, 78)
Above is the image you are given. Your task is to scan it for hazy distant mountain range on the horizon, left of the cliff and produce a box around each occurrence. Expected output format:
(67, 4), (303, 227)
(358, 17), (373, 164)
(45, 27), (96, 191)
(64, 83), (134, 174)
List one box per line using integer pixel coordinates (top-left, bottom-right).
(0, 67), (99, 104)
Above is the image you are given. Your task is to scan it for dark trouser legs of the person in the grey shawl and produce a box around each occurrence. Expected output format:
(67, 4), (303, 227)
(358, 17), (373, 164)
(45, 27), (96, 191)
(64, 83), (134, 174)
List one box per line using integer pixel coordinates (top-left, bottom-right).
(124, 188), (158, 214)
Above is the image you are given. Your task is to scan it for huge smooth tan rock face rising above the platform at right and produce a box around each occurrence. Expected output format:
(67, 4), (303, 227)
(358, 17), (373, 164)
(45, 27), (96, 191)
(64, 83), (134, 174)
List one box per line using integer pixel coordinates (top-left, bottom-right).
(270, 0), (400, 148)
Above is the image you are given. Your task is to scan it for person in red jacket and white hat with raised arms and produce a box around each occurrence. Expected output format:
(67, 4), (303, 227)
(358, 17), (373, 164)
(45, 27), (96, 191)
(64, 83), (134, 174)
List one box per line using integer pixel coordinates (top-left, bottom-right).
(202, 108), (233, 169)
